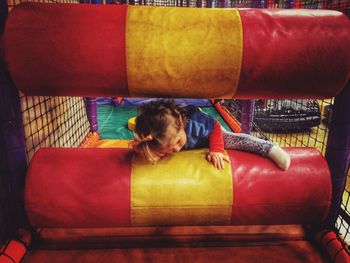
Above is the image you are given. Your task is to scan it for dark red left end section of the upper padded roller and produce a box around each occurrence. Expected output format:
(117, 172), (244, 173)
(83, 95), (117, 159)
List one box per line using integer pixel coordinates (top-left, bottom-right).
(2, 3), (129, 97)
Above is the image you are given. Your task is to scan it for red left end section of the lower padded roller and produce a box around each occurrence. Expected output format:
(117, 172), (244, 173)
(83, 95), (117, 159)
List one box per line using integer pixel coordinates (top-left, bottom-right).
(25, 148), (132, 227)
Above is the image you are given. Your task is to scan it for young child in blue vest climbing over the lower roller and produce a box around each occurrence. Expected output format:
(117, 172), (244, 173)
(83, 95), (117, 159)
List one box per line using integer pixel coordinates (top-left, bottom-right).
(131, 100), (290, 170)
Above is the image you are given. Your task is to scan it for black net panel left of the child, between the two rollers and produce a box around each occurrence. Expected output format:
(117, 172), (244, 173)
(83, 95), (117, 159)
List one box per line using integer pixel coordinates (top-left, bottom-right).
(21, 95), (90, 161)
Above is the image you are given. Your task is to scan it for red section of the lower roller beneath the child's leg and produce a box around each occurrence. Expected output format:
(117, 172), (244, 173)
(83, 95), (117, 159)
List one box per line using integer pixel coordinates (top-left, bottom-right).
(229, 148), (332, 224)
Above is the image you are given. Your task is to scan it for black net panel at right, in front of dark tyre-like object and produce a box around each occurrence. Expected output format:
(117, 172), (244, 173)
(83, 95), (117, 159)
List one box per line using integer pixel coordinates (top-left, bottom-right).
(253, 100), (333, 155)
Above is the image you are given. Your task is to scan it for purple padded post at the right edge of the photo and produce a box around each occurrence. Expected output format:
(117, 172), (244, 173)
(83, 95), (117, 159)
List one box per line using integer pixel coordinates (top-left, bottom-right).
(326, 81), (350, 227)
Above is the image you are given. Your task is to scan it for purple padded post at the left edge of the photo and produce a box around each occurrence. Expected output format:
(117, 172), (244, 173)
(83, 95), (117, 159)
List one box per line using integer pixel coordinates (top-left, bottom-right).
(0, 62), (27, 234)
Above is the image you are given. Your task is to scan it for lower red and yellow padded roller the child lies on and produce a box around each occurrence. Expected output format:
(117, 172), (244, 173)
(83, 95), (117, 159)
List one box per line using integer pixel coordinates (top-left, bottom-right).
(25, 148), (331, 228)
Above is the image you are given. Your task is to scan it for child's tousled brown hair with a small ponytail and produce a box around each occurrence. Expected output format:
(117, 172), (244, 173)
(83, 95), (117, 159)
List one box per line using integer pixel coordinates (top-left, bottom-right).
(132, 99), (185, 163)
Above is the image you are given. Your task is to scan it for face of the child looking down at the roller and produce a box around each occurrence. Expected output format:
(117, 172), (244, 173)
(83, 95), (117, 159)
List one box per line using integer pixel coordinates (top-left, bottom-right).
(155, 125), (187, 157)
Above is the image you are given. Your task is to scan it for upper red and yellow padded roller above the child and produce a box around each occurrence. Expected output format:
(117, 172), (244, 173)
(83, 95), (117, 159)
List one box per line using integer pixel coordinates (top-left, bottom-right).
(2, 3), (350, 99)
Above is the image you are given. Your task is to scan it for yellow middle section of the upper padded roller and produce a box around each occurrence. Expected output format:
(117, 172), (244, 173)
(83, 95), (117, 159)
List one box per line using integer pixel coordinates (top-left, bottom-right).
(126, 6), (243, 98)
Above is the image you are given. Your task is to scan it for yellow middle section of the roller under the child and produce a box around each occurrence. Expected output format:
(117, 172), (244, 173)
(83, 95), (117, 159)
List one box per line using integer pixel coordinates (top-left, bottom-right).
(131, 149), (233, 226)
